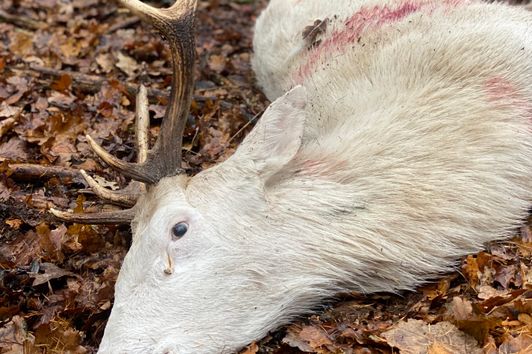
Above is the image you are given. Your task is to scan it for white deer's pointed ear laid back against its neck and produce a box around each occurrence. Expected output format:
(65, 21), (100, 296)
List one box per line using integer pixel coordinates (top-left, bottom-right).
(239, 86), (307, 176)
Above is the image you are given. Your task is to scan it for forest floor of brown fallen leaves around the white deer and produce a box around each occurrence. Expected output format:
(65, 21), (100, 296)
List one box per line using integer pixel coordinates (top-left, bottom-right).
(0, 0), (532, 354)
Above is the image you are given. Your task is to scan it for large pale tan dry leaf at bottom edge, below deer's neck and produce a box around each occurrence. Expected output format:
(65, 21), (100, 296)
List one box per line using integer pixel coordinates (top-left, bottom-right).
(382, 319), (482, 354)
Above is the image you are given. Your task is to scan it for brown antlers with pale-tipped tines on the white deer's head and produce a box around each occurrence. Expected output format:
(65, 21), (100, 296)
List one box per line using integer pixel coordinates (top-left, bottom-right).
(50, 0), (197, 224)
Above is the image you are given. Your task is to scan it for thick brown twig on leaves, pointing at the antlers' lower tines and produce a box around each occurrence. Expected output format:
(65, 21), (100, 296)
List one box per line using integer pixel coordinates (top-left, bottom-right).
(7, 163), (84, 182)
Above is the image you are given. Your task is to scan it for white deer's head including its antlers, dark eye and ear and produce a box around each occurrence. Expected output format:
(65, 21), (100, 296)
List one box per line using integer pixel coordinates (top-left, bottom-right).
(51, 0), (306, 353)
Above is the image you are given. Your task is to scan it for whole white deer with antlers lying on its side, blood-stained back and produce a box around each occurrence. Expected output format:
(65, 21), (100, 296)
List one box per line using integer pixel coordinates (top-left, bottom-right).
(47, 0), (532, 354)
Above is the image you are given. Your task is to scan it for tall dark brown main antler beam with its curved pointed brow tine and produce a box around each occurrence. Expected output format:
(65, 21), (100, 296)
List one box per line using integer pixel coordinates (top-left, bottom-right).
(87, 0), (197, 184)
